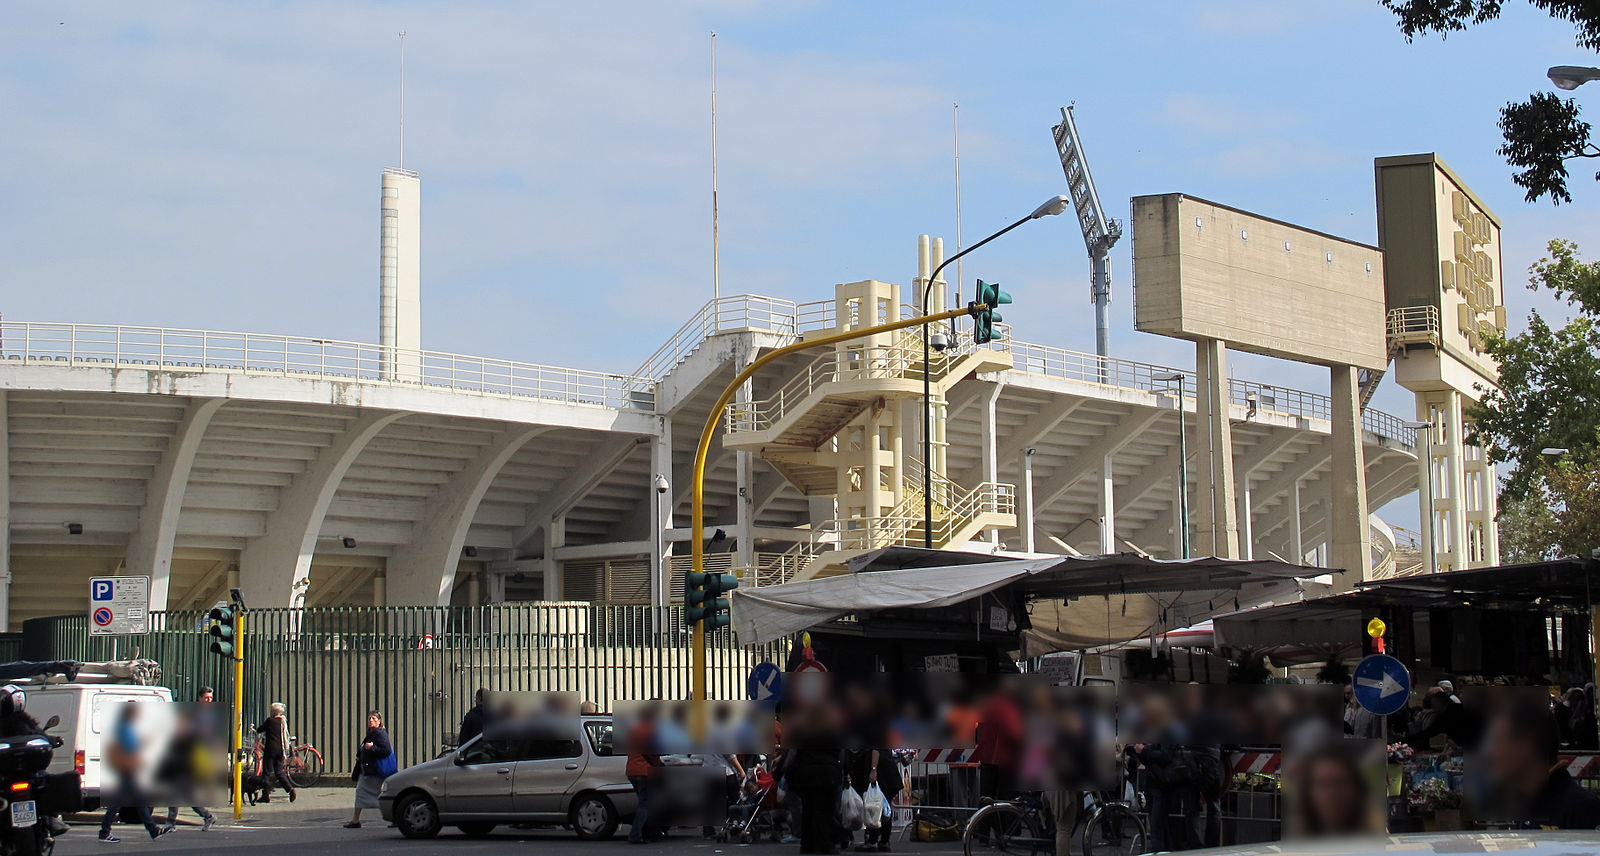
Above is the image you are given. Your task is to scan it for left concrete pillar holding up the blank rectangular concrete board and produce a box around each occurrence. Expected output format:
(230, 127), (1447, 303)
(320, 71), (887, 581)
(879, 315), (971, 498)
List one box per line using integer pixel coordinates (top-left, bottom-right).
(1192, 339), (1238, 558)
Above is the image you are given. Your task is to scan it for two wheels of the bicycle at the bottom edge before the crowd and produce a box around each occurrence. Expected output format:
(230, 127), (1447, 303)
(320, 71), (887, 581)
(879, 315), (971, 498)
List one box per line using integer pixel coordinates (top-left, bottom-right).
(962, 790), (1150, 856)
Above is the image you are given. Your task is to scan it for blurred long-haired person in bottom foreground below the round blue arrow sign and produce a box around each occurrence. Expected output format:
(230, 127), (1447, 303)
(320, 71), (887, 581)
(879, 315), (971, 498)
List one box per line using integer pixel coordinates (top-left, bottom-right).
(1286, 744), (1384, 837)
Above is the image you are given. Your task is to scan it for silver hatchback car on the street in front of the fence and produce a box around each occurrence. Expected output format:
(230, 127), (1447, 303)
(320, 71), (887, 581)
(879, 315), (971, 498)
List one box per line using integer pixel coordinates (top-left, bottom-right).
(378, 717), (638, 840)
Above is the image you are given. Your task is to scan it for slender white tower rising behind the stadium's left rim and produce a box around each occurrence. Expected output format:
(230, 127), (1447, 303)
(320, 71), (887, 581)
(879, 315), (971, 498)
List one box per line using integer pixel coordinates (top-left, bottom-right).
(378, 166), (422, 381)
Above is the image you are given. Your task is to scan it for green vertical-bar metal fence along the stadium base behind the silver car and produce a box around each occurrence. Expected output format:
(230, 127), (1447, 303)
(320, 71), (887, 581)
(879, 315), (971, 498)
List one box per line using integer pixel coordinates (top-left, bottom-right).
(24, 603), (784, 776)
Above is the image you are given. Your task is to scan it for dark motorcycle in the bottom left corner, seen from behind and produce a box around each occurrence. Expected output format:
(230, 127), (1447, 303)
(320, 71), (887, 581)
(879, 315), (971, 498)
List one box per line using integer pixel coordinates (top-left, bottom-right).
(0, 717), (83, 856)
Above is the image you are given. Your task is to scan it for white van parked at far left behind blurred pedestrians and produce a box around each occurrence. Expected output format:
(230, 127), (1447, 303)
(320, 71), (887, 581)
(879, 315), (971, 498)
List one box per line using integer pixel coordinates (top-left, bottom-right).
(21, 683), (173, 811)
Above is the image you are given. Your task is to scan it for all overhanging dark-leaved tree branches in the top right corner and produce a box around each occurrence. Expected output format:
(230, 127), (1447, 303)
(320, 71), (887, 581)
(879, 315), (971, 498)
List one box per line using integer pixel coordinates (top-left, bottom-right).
(1379, 0), (1600, 205)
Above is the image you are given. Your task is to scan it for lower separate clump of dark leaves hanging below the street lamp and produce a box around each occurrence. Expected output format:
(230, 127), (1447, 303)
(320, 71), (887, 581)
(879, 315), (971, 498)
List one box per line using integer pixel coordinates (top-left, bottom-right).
(1496, 93), (1600, 205)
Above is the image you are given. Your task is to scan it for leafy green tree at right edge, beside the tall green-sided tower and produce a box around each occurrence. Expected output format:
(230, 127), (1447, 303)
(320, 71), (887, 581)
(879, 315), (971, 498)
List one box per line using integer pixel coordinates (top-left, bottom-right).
(1467, 238), (1600, 504)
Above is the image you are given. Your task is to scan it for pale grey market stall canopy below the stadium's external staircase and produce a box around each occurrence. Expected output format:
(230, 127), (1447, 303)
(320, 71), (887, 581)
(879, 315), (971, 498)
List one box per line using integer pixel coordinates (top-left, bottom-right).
(730, 547), (1326, 654)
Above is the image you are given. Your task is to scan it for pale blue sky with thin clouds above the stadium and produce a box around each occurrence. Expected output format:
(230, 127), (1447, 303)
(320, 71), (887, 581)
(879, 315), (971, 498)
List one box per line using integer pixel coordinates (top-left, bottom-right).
(0, 0), (1600, 414)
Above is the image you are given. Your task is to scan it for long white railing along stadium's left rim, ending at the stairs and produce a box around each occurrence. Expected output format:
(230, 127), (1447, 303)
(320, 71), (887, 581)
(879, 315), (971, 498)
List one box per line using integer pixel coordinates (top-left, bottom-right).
(0, 322), (656, 411)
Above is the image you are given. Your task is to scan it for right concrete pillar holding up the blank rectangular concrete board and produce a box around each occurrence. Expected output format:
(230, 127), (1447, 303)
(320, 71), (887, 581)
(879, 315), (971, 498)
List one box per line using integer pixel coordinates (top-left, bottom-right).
(1328, 365), (1373, 592)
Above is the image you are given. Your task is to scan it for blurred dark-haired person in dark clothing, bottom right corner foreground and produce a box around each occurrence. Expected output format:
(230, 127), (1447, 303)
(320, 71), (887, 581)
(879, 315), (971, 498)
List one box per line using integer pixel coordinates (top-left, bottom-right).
(1483, 699), (1600, 829)
